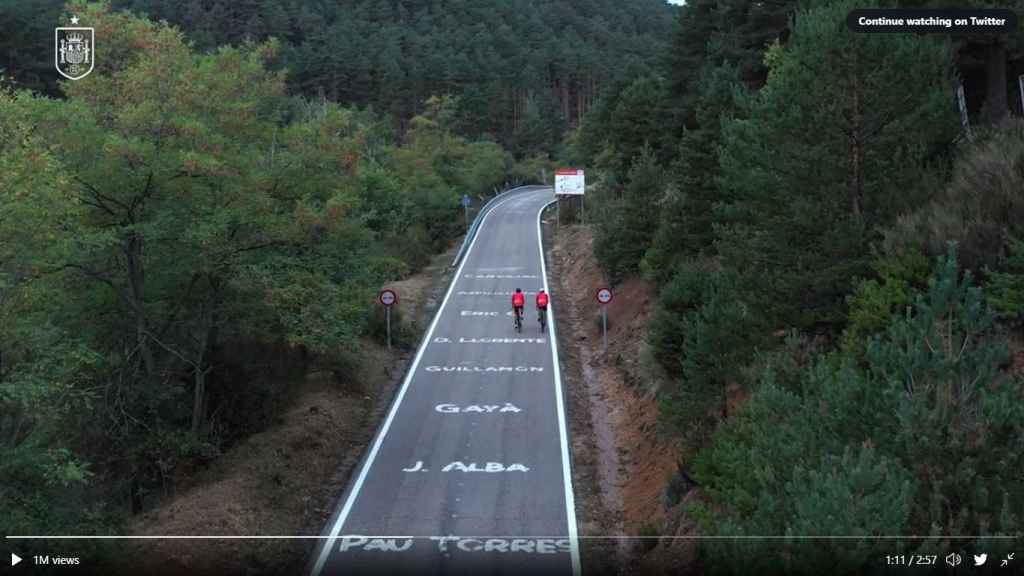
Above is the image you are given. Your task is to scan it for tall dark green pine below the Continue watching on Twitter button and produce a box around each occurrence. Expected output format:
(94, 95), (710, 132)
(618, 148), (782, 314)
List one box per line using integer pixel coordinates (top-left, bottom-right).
(718, 0), (955, 328)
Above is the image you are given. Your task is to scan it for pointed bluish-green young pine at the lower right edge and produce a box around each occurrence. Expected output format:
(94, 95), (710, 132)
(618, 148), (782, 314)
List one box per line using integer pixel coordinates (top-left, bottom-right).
(867, 243), (1024, 534)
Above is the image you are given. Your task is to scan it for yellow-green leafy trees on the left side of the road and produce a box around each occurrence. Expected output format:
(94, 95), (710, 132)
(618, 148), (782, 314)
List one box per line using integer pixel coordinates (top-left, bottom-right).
(0, 2), (638, 553)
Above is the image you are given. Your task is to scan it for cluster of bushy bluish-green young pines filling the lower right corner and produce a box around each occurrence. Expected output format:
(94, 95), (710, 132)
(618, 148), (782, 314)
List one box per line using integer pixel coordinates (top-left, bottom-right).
(693, 243), (1024, 574)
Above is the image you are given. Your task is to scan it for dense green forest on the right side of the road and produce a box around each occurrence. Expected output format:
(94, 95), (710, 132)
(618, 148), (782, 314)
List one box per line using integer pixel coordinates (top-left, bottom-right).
(571, 0), (1024, 574)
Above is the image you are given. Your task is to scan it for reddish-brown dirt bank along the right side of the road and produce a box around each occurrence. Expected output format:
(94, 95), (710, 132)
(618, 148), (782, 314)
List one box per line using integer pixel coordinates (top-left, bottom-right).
(546, 222), (696, 574)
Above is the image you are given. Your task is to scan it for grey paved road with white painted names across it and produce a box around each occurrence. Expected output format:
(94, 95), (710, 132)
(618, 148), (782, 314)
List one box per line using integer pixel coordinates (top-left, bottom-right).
(310, 188), (579, 576)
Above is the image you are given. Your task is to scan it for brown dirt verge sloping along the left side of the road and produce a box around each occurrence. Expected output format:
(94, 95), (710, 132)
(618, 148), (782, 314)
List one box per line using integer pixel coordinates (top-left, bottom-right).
(119, 246), (458, 576)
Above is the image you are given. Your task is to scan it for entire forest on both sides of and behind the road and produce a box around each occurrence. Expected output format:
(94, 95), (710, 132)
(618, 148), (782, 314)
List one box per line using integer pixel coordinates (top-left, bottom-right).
(0, 0), (1024, 574)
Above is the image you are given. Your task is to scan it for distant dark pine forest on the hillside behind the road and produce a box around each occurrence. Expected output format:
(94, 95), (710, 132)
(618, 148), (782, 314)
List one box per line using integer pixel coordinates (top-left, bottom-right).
(0, 0), (672, 155)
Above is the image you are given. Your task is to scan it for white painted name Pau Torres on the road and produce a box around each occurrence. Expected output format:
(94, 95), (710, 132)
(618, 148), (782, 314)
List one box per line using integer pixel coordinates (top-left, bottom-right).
(338, 535), (571, 554)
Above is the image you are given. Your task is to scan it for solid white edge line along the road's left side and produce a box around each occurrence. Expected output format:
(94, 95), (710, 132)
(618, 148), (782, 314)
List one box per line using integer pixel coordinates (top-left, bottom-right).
(312, 190), (524, 576)
